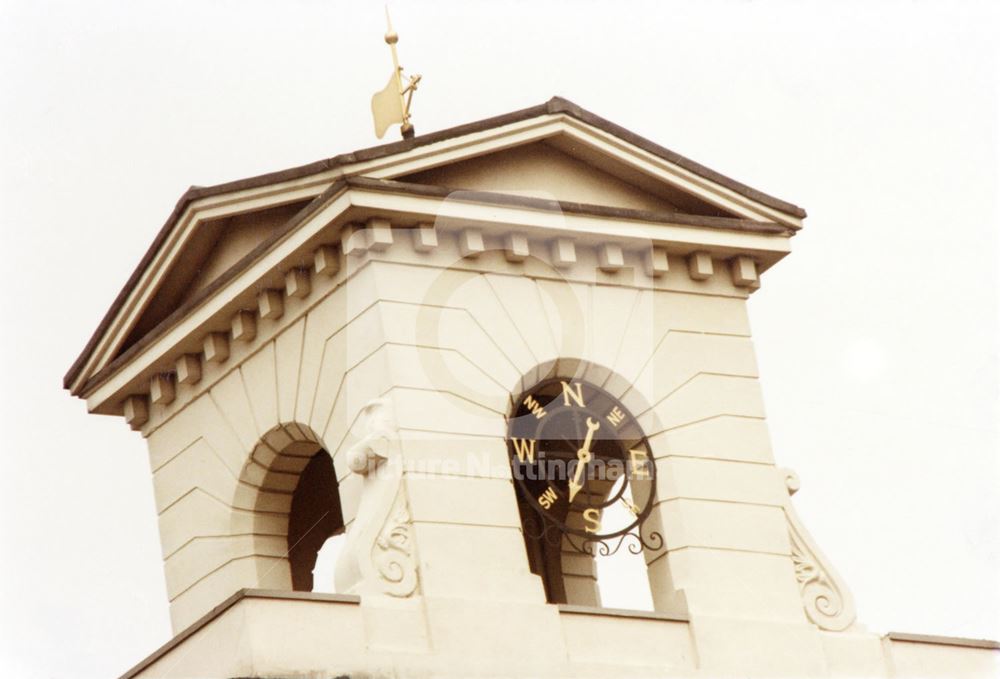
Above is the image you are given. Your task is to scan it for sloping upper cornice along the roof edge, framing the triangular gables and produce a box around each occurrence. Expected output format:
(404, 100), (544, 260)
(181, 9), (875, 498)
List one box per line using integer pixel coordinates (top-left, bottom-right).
(64, 98), (805, 395)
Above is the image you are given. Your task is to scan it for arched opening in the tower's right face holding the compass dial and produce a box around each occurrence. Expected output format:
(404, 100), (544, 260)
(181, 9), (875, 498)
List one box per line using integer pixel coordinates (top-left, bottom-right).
(508, 362), (663, 610)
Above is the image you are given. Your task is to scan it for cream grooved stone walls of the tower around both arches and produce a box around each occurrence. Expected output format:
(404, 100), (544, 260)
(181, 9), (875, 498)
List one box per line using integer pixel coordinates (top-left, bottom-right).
(144, 223), (788, 629)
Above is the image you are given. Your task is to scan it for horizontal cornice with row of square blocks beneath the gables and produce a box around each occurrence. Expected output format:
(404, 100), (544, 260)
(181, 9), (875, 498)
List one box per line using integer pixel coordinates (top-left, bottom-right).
(80, 178), (789, 428)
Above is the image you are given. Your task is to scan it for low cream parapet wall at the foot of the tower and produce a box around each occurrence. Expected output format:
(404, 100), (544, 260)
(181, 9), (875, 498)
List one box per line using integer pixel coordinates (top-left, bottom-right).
(123, 591), (1000, 679)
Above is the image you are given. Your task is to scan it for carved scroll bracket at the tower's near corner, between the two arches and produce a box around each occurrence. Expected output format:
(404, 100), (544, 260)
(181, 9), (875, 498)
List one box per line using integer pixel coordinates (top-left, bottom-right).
(335, 398), (418, 597)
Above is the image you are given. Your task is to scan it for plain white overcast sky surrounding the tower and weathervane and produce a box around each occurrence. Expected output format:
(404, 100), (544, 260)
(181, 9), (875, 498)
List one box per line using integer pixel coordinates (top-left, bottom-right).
(0, 0), (1000, 679)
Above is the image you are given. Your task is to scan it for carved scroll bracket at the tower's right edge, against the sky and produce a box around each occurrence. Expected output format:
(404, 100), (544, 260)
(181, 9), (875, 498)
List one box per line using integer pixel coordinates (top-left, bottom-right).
(779, 469), (856, 632)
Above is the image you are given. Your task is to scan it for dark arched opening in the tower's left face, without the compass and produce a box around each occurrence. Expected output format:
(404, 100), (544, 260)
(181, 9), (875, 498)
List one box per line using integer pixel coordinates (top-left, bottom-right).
(288, 449), (344, 592)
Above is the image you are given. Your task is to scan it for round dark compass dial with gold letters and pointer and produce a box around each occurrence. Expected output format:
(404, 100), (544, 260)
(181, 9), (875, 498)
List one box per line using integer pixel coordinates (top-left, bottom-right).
(507, 379), (656, 540)
